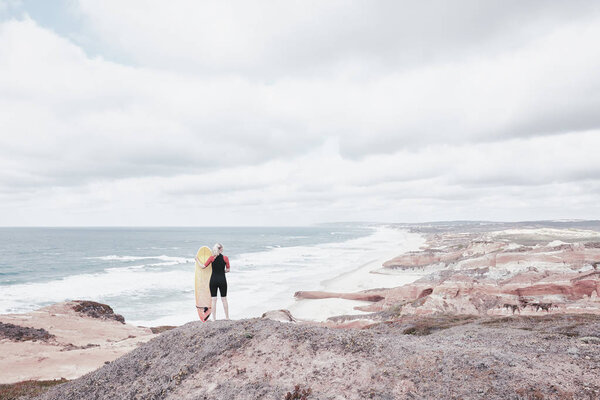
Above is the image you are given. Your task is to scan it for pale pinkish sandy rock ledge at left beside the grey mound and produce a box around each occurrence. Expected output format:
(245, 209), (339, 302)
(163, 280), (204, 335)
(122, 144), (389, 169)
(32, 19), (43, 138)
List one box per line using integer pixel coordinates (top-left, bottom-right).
(0, 301), (155, 384)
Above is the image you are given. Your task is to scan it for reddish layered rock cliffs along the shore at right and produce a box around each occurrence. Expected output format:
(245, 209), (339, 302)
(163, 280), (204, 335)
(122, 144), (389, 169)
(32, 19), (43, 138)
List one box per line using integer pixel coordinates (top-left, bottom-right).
(318, 230), (600, 324)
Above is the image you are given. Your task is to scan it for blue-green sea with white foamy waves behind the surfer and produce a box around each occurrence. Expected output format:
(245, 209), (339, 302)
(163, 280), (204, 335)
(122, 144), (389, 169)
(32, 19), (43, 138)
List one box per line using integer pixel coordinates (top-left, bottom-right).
(0, 224), (406, 326)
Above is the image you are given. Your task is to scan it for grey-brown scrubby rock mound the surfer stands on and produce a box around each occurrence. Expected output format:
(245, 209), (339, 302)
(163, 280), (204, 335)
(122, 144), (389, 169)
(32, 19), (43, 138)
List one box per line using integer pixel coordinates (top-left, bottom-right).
(30, 315), (600, 400)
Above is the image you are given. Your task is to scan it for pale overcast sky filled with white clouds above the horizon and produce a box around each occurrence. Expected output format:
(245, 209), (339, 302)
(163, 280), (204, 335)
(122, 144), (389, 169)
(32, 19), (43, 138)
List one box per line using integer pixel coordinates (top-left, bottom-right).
(0, 0), (600, 226)
